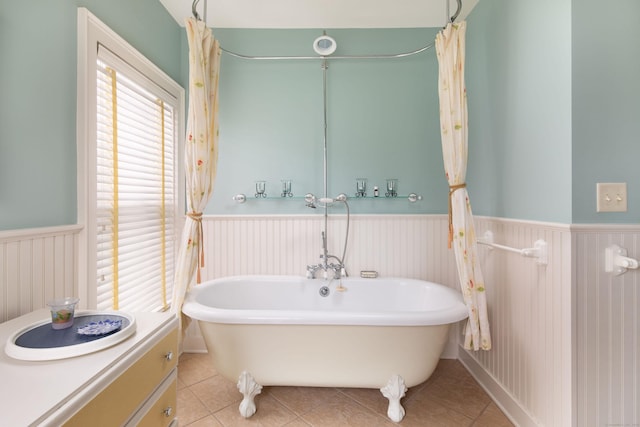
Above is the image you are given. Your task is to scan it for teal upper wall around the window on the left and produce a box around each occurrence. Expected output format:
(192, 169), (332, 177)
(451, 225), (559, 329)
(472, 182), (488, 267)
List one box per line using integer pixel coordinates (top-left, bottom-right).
(0, 0), (184, 230)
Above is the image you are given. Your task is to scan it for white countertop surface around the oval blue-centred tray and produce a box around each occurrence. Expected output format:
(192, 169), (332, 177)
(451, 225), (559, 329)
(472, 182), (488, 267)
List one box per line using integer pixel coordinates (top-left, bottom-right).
(0, 309), (177, 427)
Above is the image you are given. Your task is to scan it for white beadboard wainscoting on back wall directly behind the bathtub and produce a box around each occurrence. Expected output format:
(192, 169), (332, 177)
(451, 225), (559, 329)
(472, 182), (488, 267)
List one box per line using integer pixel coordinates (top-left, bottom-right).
(202, 215), (458, 289)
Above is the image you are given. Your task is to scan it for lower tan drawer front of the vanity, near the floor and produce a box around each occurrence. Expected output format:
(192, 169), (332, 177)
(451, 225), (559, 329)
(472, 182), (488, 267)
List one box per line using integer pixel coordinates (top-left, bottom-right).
(127, 369), (178, 427)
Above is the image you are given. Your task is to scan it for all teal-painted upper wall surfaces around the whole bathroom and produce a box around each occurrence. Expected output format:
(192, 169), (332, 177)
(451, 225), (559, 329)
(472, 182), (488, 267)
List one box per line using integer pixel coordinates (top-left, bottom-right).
(5, 0), (640, 230)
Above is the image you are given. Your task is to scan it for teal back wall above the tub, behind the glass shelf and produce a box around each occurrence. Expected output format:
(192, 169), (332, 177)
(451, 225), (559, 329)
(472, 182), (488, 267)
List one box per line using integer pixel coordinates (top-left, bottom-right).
(206, 29), (447, 214)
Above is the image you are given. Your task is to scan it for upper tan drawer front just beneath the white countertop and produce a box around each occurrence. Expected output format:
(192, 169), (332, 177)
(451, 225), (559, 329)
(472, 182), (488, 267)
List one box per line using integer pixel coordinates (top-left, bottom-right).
(64, 328), (178, 427)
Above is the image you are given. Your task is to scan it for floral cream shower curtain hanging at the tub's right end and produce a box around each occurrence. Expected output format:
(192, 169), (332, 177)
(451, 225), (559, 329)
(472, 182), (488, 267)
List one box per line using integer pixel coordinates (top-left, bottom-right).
(436, 21), (491, 350)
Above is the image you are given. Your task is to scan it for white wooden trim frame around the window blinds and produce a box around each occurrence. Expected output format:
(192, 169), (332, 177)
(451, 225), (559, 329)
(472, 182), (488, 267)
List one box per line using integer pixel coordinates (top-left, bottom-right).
(76, 7), (185, 309)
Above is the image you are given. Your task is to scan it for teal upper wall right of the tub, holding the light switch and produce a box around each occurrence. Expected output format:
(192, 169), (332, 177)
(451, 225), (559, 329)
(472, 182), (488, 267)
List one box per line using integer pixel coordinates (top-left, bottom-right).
(467, 0), (640, 223)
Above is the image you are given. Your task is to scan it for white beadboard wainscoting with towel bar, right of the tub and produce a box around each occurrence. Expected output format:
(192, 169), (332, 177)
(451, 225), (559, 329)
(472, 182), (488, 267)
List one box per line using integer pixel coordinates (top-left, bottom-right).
(460, 218), (573, 426)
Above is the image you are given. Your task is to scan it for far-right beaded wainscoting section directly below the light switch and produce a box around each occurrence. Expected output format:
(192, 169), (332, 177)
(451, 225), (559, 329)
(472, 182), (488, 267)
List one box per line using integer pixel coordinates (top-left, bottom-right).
(574, 225), (640, 426)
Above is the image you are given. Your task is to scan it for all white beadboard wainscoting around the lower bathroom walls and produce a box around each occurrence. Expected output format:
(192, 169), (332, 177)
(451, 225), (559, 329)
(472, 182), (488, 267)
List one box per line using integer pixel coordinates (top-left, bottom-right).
(0, 215), (640, 427)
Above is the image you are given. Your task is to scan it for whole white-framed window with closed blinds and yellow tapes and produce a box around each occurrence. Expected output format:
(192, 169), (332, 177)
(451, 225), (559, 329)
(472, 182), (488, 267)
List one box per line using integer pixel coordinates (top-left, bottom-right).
(78, 9), (184, 311)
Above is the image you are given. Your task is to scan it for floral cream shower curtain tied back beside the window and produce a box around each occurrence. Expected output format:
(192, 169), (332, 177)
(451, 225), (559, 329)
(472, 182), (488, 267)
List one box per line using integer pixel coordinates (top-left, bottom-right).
(171, 18), (221, 331)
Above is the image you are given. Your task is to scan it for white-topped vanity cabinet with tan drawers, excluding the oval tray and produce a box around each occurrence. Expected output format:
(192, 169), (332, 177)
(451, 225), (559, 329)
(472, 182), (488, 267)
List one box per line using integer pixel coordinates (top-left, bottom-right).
(0, 310), (178, 427)
